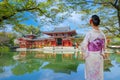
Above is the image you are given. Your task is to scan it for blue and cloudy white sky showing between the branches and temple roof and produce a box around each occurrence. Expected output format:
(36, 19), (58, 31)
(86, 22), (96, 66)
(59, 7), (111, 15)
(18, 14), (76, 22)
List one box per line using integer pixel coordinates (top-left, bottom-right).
(18, 9), (91, 34)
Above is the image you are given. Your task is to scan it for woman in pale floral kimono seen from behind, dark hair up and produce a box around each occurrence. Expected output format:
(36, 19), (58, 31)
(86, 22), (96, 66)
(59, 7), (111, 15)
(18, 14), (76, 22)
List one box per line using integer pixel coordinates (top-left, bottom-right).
(81, 15), (106, 80)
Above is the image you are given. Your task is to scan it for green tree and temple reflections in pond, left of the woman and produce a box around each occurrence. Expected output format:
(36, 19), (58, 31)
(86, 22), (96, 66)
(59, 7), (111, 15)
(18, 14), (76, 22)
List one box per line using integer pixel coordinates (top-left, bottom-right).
(12, 52), (84, 75)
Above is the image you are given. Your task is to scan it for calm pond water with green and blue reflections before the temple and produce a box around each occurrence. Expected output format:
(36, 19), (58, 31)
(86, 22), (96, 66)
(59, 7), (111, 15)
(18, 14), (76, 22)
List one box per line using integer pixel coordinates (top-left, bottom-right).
(0, 51), (120, 80)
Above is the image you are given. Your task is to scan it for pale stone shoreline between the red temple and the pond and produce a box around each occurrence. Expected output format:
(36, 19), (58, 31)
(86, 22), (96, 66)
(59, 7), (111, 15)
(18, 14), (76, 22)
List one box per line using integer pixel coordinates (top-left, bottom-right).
(16, 46), (115, 53)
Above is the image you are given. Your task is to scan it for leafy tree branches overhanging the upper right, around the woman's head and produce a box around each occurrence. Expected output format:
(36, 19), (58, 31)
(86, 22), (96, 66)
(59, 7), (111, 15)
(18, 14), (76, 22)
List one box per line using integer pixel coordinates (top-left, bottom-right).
(63, 0), (120, 37)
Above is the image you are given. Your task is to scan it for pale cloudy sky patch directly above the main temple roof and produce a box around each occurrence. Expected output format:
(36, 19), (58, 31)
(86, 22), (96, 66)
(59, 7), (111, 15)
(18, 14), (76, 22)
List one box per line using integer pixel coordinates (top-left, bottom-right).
(41, 12), (89, 34)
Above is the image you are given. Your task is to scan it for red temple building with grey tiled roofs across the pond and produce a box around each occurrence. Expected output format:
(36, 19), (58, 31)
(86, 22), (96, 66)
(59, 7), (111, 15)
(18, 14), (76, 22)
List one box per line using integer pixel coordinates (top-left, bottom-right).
(18, 27), (76, 48)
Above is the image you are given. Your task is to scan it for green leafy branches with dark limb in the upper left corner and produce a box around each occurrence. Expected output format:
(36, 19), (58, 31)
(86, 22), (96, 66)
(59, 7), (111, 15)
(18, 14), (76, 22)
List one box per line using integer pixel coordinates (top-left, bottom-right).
(0, 0), (52, 24)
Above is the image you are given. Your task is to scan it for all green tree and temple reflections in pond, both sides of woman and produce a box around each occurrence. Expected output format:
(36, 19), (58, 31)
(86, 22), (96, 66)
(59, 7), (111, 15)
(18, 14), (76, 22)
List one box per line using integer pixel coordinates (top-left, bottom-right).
(12, 52), (120, 75)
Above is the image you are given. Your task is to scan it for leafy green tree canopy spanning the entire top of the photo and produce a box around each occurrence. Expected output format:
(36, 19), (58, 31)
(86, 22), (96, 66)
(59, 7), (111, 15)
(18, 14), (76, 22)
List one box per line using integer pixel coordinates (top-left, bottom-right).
(0, 0), (120, 36)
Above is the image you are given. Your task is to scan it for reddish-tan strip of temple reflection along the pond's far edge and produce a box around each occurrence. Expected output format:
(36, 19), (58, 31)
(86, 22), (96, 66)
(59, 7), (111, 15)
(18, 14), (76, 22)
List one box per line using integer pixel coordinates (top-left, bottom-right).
(16, 51), (83, 60)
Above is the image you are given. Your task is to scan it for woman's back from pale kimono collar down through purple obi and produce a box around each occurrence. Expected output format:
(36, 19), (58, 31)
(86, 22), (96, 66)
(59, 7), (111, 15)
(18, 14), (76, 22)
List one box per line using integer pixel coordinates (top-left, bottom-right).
(88, 29), (105, 51)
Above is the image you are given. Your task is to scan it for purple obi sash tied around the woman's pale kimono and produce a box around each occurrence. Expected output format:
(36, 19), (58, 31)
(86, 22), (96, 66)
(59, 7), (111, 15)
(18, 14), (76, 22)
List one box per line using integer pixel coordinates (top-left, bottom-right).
(88, 38), (105, 51)
